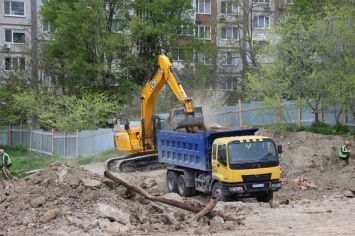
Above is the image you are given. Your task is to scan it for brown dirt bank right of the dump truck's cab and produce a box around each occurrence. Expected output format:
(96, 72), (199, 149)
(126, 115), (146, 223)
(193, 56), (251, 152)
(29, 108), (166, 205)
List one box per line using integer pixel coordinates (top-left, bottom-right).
(258, 130), (355, 200)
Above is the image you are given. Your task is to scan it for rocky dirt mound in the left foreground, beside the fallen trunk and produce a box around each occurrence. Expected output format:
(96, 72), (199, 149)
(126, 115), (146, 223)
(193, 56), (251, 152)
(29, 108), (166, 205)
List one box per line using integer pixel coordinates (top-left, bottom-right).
(0, 163), (242, 235)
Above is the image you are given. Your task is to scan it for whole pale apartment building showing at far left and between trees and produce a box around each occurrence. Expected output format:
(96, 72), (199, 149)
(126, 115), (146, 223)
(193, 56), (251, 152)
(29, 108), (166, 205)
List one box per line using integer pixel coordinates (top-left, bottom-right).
(0, 0), (293, 90)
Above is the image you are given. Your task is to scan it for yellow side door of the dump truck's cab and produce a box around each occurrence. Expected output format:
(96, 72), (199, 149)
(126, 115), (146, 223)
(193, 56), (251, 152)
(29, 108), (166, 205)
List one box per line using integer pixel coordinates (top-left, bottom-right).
(212, 145), (228, 181)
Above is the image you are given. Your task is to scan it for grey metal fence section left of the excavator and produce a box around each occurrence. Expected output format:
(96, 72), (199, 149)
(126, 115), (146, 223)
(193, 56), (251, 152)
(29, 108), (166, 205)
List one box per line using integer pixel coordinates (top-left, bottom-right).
(0, 126), (117, 157)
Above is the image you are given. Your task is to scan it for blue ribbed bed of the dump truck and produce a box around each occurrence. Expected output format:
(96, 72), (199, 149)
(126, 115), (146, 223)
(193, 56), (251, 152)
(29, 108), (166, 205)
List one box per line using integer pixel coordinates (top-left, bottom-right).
(157, 128), (258, 171)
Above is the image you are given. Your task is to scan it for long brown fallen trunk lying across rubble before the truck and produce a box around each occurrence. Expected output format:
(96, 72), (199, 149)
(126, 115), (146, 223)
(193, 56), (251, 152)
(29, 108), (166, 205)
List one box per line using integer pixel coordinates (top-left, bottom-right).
(104, 171), (243, 225)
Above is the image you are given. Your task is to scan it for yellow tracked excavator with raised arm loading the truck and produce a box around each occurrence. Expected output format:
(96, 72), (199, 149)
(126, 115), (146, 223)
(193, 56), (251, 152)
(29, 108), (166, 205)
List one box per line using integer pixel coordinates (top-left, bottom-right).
(105, 55), (205, 172)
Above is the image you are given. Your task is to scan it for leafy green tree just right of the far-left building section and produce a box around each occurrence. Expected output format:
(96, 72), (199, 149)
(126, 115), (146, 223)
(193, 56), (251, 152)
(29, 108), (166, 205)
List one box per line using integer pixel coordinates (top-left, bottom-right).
(42, 0), (126, 94)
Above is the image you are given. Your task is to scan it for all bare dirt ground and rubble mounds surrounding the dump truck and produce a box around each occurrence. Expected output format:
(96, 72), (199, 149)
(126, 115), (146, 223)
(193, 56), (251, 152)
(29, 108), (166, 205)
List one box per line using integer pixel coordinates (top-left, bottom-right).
(0, 130), (355, 236)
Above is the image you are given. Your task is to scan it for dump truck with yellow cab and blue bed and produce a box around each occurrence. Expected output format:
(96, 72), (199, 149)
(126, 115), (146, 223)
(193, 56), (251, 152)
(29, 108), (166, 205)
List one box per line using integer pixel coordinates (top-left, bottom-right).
(157, 127), (282, 202)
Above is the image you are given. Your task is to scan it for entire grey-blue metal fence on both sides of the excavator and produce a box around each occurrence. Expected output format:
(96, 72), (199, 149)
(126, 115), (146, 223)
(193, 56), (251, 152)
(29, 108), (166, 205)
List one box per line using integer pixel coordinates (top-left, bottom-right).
(0, 100), (354, 158)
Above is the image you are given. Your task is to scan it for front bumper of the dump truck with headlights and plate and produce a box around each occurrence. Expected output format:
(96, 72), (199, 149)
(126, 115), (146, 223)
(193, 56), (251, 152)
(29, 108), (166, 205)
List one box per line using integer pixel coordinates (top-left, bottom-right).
(222, 180), (282, 196)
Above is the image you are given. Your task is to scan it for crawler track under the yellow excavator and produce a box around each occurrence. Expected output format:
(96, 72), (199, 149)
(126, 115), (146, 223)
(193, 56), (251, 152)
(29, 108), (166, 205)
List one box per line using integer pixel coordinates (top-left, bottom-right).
(105, 151), (166, 173)
